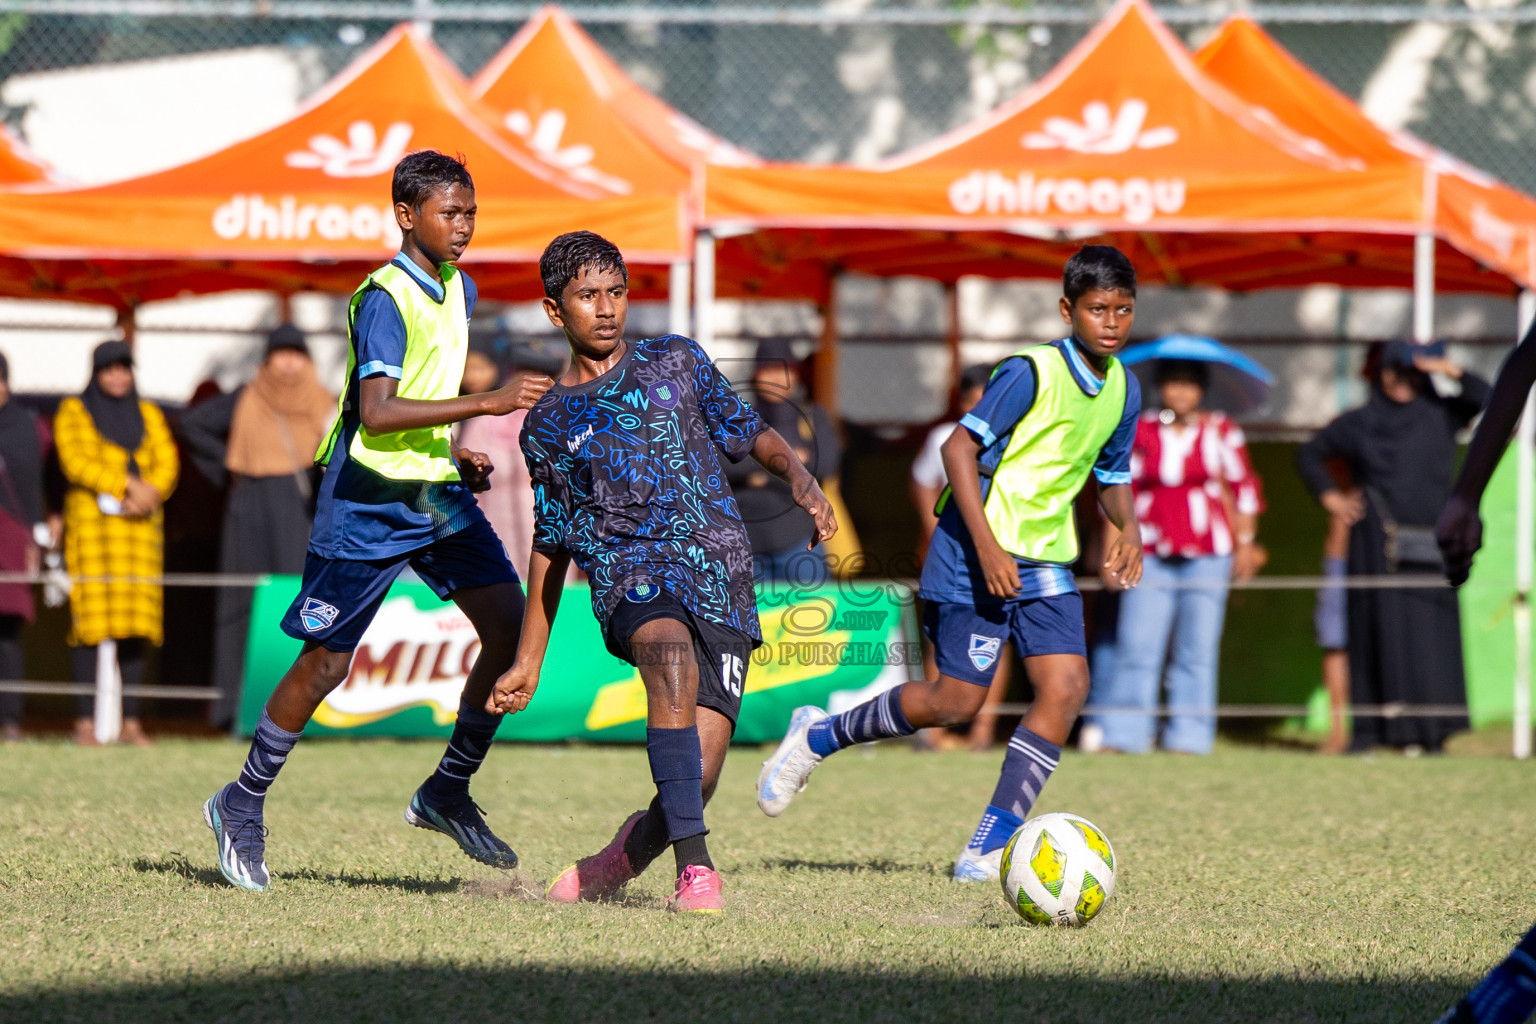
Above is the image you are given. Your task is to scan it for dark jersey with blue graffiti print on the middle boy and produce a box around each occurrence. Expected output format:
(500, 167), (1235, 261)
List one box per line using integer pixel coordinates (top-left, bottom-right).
(521, 335), (765, 640)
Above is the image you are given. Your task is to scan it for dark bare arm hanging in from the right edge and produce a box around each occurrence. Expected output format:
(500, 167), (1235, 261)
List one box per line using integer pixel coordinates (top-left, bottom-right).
(1435, 325), (1536, 586)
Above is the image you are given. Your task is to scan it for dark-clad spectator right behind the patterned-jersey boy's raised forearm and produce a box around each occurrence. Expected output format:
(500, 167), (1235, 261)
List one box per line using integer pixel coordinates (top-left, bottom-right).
(725, 338), (842, 586)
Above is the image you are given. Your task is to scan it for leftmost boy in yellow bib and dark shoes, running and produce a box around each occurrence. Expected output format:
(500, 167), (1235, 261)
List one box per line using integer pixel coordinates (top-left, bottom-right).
(203, 150), (551, 890)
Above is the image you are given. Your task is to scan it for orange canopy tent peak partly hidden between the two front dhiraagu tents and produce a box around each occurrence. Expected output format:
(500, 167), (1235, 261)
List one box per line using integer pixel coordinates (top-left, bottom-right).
(470, 5), (762, 333)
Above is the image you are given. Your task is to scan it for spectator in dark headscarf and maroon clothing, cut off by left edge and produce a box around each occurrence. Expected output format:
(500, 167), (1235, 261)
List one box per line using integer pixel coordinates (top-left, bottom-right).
(0, 355), (57, 743)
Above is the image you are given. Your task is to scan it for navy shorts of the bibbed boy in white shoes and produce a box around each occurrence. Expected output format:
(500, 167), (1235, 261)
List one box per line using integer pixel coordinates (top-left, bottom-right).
(923, 591), (1087, 686)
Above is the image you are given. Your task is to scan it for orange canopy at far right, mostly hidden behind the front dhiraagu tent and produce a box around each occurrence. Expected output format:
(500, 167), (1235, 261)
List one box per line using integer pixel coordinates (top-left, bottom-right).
(1195, 15), (1536, 338)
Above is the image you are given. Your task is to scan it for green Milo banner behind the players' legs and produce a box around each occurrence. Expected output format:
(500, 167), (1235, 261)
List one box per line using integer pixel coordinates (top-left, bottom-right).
(240, 576), (923, 743)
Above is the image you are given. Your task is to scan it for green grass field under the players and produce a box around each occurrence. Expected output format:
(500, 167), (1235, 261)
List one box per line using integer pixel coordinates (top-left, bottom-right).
(0, 742), (1536, 1024)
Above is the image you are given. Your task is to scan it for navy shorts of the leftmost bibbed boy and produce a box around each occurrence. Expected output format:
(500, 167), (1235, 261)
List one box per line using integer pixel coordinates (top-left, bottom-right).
(283, 517), (518, 651)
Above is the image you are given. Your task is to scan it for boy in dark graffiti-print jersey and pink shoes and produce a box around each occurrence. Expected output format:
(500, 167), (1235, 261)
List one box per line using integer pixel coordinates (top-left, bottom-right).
(487, 232), (837, 913)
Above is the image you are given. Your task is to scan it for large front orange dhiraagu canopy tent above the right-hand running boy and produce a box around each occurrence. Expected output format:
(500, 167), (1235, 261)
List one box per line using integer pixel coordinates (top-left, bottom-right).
(703, 0), (1528, 323)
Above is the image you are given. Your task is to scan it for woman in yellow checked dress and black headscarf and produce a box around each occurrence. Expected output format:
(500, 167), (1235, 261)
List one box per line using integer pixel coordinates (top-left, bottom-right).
(54, 341), (180, 745)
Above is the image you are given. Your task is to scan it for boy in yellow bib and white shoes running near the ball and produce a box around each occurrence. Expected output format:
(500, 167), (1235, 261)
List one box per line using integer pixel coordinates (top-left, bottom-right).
(757, 246), (1141, 881)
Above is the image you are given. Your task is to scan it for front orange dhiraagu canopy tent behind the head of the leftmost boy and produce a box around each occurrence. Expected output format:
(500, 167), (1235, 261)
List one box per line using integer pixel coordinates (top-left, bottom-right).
(0, 26), (690, 309)
